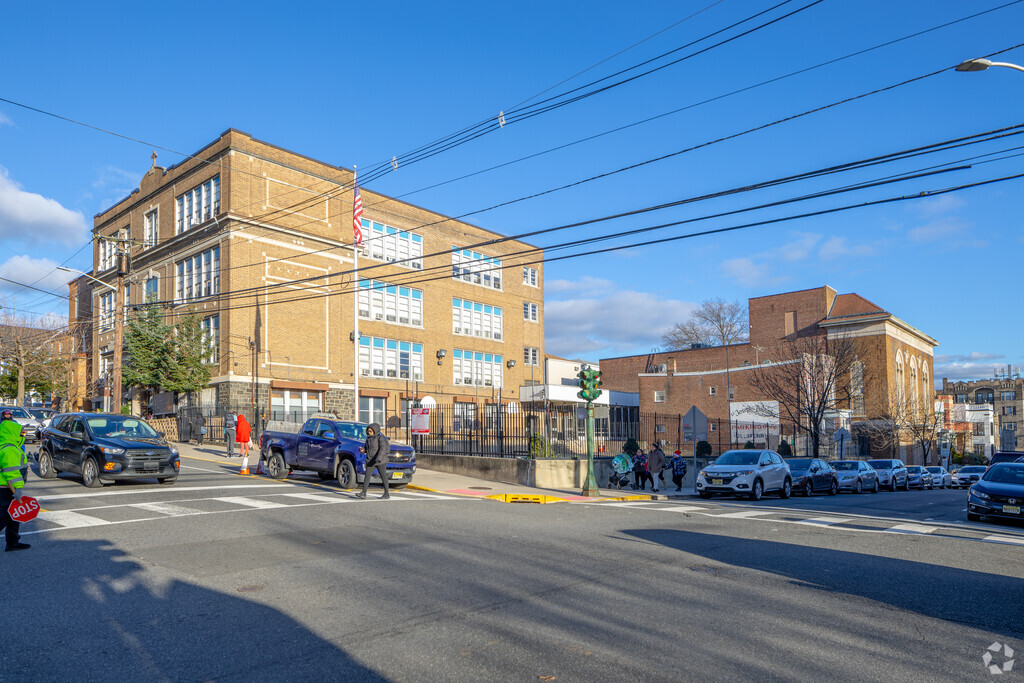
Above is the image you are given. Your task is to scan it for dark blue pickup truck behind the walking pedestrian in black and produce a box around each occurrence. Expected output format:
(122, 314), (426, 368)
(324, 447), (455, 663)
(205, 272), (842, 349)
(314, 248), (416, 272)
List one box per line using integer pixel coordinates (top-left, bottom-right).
(259, 417), (416, 488)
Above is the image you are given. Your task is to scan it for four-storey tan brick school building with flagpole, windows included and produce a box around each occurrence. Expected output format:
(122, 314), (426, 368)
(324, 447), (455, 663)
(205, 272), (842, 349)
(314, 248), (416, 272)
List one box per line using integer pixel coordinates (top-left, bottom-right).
(91, 129), (544, 422)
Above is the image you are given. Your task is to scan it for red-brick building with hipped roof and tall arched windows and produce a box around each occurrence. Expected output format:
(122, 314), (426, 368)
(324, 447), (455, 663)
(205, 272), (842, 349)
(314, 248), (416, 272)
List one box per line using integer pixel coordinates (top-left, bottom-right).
(601, 287), (938, 462)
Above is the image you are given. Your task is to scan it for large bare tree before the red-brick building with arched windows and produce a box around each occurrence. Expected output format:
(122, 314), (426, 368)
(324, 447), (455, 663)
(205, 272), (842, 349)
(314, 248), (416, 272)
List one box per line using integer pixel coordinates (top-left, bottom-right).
(749, 335), (859, 458)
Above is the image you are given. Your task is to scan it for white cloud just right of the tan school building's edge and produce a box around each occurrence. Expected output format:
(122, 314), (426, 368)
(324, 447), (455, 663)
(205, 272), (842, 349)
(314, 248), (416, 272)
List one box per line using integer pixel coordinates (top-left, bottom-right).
(544, 290), (696, 357)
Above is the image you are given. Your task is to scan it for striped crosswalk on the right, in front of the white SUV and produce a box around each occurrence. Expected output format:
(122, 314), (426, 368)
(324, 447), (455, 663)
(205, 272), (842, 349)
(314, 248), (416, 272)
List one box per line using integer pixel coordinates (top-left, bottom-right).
(573, 501), (1024, 546)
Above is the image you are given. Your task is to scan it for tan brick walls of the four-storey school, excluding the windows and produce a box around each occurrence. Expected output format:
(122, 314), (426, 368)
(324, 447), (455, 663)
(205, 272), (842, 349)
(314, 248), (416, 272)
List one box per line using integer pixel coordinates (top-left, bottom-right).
(93, 130), (544, 414)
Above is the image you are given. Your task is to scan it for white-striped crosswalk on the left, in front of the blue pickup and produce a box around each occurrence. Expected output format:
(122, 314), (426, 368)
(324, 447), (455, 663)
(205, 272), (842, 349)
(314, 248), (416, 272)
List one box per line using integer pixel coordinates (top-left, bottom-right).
(22, 486), (467, 536)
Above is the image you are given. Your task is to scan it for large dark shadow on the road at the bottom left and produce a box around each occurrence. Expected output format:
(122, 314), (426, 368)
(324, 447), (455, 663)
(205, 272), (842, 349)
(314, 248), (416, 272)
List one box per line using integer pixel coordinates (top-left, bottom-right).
(4, 541), (384, 681)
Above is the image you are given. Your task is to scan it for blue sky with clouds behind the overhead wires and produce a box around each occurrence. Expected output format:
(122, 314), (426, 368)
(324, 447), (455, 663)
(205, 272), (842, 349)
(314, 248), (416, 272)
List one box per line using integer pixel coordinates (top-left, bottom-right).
(0, 0), (1024, 380)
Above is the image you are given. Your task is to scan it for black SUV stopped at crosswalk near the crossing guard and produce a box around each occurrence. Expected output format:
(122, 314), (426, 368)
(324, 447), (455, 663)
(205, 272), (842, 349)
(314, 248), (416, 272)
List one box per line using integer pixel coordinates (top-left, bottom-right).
(36, 413), (180, 487)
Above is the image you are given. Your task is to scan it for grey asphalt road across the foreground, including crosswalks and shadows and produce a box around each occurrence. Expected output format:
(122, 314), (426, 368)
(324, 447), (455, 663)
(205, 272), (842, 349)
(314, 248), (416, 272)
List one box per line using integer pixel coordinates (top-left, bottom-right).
(3, 456), (1024, 681)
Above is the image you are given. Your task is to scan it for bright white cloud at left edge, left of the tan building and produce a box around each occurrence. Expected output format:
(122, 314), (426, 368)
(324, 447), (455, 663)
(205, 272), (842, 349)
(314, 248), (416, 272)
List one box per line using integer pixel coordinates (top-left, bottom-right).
(0, 167), (88, 247)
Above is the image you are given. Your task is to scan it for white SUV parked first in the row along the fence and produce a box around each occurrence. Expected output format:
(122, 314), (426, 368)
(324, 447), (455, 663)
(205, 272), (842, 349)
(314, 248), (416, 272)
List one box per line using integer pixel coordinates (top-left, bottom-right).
(697, 451), (793, 501)
